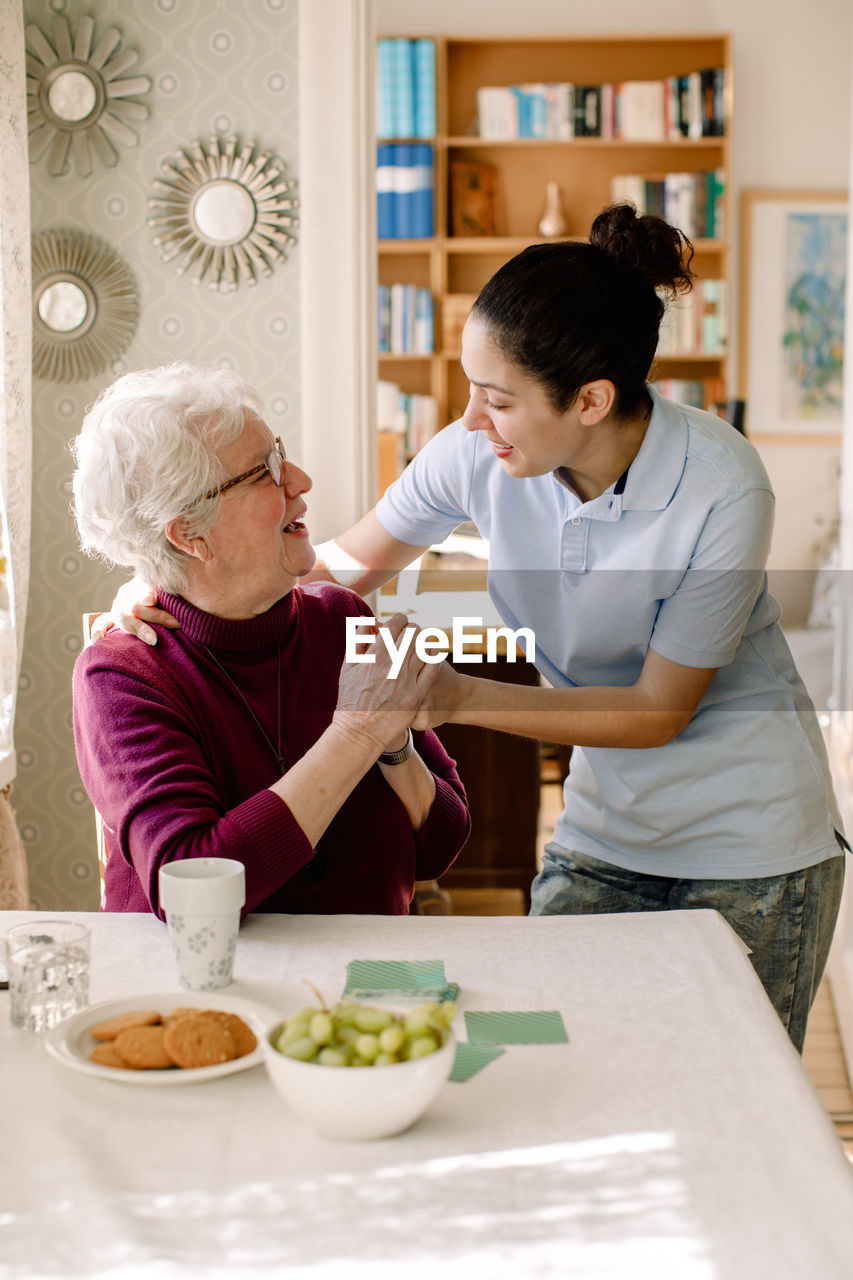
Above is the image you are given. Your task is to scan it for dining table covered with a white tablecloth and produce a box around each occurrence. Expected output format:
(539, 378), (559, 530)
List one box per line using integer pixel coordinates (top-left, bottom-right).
(0, 911), (853, 1280)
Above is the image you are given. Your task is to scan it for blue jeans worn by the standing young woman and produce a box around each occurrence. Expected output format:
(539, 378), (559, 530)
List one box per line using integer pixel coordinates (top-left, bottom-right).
(530, 844), (844, 1053)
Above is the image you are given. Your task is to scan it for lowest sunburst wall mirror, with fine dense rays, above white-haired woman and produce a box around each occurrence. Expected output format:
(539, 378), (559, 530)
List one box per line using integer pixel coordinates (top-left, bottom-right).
(32, 230), (140, 383)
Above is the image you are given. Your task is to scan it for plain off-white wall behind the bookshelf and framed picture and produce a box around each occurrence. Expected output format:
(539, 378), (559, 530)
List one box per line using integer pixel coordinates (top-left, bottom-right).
(375, 0), (853, 625)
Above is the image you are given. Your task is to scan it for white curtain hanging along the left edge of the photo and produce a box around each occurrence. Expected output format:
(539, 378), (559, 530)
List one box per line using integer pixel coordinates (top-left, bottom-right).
(0, 0), (32, 910)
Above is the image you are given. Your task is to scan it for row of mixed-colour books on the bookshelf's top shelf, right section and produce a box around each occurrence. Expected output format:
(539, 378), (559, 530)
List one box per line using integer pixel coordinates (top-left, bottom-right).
(476, 67), (725, 142)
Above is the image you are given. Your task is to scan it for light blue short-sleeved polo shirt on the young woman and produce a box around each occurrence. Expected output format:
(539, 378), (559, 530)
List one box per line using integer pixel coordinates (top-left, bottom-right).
(377, 385), (841, 879)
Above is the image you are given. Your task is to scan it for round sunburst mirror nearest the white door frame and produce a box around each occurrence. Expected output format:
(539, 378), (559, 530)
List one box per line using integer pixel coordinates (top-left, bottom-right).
(149, 134), (298, 293)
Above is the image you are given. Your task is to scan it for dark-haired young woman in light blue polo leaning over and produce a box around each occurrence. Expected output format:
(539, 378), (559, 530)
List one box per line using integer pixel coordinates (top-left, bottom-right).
(108, 205), (844, 1048)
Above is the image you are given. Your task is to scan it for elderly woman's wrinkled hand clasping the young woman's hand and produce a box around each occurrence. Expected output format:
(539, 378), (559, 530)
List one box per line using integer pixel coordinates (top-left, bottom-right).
(334, 613), (439, 751)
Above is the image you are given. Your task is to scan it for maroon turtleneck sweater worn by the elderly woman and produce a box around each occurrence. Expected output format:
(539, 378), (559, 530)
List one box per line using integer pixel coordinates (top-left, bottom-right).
(74, 584), (469, 915)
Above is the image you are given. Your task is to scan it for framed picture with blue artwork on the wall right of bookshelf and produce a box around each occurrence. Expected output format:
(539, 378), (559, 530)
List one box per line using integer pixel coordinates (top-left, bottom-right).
(739, 191), (848, 443)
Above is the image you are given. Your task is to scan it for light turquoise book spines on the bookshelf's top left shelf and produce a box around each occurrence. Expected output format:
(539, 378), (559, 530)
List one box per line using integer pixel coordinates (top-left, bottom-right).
(377, 40), (435, 138)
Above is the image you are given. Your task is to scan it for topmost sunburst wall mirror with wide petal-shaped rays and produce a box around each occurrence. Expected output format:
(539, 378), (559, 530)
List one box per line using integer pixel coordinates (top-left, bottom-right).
(27, 14), (151, 178)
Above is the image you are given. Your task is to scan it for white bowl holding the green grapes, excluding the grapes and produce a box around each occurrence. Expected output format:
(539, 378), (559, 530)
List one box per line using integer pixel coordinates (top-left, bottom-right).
(260, 1023), (456, 1142)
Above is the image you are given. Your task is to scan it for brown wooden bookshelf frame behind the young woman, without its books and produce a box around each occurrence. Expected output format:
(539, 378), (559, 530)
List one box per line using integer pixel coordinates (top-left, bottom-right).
(378, 33), (733, 492)
